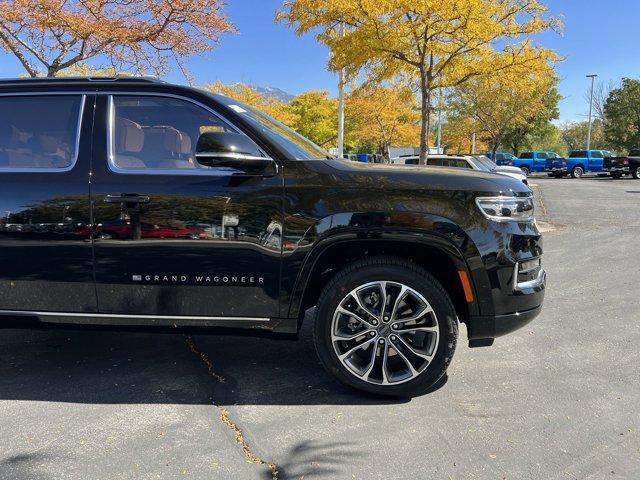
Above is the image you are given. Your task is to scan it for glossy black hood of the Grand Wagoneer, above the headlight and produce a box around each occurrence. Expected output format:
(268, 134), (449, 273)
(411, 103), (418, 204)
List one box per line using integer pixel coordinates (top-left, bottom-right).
(323, 159), (531, 196)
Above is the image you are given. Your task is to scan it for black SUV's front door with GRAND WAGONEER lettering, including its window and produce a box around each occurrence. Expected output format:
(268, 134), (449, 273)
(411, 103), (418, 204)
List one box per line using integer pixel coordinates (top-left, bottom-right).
(91, 94), (283, 319)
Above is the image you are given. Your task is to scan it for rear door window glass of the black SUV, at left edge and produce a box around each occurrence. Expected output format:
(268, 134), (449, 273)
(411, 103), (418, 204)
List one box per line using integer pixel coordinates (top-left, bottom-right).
(0, 95), (82, 170)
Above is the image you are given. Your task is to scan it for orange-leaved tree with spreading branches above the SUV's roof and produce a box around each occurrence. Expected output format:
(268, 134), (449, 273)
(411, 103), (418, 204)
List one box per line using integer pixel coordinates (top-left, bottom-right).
(0, 0), (234, 77)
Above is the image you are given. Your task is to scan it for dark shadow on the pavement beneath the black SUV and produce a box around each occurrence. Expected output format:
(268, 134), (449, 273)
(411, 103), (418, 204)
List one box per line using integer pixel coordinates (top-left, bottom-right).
(0, 325), (447, 405)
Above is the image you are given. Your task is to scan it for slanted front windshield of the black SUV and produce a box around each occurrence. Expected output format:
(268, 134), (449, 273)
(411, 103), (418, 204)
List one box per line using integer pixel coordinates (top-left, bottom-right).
(215, 95), (333, 160)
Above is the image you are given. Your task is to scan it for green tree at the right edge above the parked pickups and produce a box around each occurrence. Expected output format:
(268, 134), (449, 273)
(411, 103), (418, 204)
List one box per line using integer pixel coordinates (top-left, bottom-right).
(604, 78), (640, 150)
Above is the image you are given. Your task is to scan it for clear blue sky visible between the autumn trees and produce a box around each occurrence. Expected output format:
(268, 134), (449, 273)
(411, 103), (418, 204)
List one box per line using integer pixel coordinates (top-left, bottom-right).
(0, 0), (640, 121)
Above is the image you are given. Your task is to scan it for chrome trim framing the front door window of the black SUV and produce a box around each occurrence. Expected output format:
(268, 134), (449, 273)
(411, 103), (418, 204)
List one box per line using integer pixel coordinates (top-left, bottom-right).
(104, 91), (272, 177)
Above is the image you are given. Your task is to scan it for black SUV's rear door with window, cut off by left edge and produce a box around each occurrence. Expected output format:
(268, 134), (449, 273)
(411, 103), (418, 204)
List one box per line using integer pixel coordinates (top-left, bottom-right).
(0, 91), (96, 313)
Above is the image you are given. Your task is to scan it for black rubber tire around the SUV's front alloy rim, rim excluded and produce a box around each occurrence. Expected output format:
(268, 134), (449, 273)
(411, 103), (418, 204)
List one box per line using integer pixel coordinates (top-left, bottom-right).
(313, 257), (458, 397)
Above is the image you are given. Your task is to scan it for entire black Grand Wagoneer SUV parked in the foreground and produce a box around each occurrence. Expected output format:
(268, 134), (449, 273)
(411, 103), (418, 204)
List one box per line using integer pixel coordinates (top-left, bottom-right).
(0, 78), (545, 396)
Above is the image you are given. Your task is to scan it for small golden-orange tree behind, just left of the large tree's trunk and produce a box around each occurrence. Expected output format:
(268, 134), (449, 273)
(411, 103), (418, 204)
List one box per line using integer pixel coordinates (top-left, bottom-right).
(346, 83), (420, 157)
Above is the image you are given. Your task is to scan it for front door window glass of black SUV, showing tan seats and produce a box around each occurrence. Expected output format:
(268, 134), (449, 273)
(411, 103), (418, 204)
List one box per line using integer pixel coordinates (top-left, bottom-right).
(110, 96), (258, 171)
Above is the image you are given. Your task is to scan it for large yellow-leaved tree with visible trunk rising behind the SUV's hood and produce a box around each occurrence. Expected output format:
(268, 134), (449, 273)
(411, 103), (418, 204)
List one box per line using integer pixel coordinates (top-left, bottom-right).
(276, 0), (560, 163)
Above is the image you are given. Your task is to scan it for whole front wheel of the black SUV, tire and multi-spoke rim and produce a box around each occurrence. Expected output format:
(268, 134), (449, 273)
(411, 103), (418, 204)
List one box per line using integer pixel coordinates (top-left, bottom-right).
(314, 257), (458, 397)
